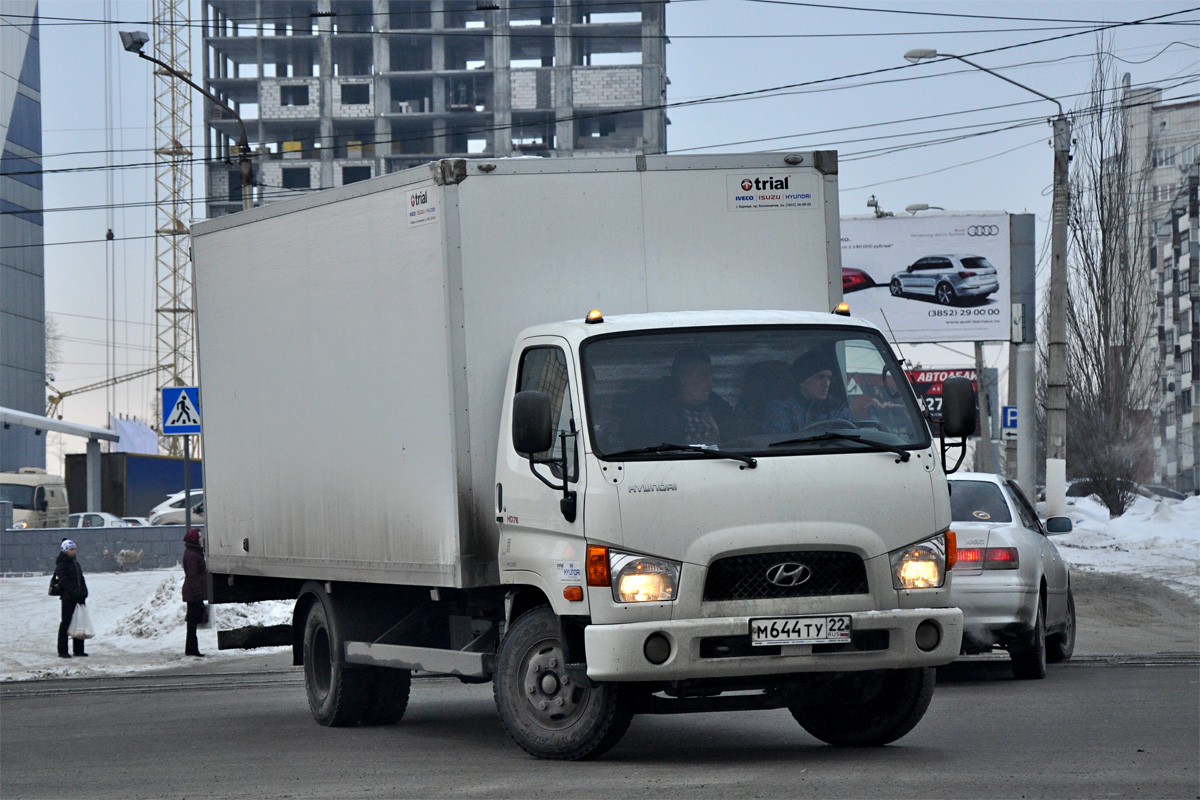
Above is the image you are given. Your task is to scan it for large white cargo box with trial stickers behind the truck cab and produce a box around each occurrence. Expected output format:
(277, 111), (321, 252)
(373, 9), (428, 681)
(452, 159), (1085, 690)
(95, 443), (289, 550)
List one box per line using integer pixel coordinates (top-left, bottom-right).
(193, 152), (841, 588)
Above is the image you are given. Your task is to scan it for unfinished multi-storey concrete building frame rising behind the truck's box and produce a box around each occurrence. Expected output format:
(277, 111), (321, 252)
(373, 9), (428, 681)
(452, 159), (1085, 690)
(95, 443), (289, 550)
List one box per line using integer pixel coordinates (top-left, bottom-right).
(202, 0), (667, 216)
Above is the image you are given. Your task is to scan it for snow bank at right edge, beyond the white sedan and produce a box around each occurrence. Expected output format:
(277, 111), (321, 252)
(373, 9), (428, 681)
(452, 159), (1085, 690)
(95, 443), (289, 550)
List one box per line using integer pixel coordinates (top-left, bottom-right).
(1052, 497), (1200, 600)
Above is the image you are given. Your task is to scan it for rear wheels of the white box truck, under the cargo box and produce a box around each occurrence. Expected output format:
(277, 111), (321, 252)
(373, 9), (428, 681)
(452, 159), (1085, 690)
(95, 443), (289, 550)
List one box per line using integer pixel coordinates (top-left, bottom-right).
(304, 600), (372, 728)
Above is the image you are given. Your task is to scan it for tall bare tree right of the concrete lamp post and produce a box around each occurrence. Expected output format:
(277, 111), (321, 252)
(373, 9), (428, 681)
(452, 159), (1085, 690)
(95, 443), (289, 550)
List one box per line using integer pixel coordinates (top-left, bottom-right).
(1067, 46), (1160, 516)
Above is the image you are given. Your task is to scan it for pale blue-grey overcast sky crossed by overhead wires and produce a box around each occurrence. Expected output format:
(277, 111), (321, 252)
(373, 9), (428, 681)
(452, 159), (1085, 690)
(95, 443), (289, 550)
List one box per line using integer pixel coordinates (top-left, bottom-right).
(21, 0), (1200, 469)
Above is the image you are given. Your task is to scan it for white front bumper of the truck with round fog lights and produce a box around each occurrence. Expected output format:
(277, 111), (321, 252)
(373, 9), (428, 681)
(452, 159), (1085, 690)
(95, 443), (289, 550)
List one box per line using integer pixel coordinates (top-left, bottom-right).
(583, 608), (962, 681)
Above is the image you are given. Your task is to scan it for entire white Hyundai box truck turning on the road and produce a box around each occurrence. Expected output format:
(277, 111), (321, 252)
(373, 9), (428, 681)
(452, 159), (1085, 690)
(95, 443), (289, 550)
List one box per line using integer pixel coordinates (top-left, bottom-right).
(193, 152), (973, 759)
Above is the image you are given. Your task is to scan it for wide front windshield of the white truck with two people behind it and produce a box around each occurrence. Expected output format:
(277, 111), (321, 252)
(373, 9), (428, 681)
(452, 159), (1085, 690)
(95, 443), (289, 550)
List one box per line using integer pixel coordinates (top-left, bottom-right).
(581, 326), (930, 459)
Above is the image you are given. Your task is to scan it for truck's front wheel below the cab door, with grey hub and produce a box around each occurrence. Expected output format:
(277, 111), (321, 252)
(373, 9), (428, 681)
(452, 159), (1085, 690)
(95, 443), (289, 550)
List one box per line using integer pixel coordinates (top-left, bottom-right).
(493, 606), (632, 760)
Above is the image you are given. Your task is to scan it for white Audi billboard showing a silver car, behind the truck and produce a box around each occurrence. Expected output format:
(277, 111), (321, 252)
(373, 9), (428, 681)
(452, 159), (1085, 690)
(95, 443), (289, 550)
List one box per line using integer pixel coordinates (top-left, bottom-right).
(841, 211), (1013, 342)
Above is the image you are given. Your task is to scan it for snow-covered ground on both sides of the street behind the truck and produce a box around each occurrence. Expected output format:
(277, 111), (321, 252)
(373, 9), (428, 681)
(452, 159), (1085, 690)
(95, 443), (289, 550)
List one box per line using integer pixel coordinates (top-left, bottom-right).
(0, 497), (1200, 680)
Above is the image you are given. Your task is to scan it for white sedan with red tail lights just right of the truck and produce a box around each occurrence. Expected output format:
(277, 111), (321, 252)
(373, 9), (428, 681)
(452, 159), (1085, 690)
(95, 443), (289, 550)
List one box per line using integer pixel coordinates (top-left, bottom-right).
(949, 473), (1075, 679)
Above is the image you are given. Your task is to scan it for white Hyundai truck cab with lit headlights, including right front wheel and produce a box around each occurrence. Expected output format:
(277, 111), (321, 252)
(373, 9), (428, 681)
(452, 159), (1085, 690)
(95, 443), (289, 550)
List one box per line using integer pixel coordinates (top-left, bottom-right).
(496, 311), (962, 762)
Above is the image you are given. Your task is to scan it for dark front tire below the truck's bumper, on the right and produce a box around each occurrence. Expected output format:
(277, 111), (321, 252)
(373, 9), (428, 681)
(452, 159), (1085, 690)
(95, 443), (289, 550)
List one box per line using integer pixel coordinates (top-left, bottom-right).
(787, 667), (936, 747)
